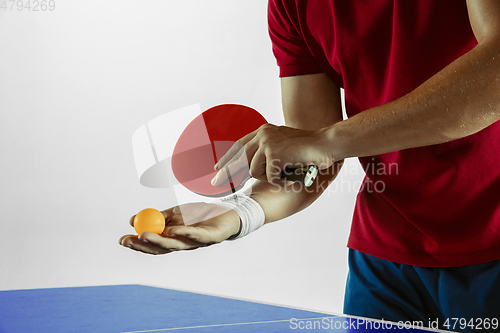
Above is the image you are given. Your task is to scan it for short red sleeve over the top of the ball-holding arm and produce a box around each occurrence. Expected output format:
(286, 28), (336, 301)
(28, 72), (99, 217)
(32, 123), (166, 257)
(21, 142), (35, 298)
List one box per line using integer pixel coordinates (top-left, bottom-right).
(268, 0), (323, 77)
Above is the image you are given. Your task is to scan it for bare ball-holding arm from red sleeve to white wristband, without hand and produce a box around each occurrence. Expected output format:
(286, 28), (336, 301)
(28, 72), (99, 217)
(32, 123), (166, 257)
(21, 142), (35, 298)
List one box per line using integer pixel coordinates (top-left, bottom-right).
(251, 73), (342, 223)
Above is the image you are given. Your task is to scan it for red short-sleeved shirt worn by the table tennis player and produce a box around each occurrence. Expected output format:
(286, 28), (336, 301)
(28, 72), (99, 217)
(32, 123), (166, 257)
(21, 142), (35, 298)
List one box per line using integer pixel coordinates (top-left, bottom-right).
(269, 0), (500, 267)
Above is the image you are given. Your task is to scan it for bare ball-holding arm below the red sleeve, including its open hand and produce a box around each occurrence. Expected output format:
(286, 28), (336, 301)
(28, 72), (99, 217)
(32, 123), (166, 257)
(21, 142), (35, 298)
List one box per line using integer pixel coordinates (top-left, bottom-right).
(119, 74), (342, 254)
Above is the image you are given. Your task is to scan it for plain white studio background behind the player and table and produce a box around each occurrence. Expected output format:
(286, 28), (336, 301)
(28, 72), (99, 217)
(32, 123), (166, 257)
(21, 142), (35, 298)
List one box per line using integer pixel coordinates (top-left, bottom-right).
(0, 0), (362, 313)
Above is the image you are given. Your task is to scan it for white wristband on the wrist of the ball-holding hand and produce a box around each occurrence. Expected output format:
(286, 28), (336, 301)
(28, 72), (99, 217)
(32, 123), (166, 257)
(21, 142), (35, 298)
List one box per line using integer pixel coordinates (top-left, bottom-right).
(213, 194), (266, 240)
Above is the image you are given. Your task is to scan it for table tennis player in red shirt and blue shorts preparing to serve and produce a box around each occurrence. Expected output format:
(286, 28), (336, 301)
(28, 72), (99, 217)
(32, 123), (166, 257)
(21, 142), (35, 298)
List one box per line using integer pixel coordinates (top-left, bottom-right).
(120, 0), (500, 332)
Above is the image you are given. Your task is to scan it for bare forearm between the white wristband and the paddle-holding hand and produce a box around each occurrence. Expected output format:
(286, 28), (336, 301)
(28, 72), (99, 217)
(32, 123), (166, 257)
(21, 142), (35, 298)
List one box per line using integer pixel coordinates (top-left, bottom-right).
(247, 161), (343, 223)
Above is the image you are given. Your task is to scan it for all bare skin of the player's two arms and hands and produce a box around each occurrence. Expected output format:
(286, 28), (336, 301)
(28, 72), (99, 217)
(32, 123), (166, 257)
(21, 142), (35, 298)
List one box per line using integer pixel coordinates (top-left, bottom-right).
(120, 0), (500, 254)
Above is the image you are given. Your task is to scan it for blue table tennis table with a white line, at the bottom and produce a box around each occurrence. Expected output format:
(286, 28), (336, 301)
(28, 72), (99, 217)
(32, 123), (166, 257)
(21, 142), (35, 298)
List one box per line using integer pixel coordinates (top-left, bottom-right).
(0, 285), (450, 333)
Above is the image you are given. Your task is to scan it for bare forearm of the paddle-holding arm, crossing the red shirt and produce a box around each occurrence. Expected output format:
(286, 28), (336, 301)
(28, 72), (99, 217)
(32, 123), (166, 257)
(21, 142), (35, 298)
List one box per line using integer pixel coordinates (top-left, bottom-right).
(324, 38), (500, 161)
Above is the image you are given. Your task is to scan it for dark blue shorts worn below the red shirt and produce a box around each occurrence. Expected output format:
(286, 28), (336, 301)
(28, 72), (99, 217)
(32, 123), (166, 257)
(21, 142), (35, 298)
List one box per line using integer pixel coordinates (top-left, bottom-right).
(344, 249), (500, 332)
